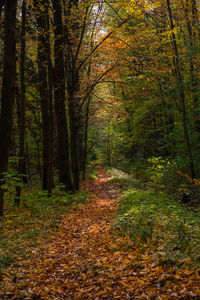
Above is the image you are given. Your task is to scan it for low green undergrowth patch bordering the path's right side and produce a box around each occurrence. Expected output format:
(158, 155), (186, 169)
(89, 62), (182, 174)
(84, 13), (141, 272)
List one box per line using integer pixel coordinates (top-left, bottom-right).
(113, 188), (200, 266)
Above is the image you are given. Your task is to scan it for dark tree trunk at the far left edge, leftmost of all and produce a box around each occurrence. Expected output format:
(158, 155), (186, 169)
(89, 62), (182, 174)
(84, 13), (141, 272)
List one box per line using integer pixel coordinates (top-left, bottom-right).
(0, 0), (17, 216)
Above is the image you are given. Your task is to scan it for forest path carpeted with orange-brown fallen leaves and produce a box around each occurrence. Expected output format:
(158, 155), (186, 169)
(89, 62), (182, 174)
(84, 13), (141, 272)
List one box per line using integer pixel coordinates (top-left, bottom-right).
(0, 167), (200, 300)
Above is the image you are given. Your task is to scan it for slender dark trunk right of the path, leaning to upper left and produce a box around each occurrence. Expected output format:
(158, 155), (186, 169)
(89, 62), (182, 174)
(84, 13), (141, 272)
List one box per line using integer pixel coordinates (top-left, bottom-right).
(166, 0), (195, 178)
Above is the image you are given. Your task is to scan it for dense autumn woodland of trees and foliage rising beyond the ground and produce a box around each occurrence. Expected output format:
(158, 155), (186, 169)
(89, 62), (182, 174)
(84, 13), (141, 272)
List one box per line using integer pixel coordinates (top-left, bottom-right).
(0, 0), (200, 215)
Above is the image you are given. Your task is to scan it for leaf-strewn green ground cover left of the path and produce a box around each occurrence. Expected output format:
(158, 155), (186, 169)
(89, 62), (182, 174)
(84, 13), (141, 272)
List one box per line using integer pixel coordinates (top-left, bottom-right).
(0, 187), (87, 270)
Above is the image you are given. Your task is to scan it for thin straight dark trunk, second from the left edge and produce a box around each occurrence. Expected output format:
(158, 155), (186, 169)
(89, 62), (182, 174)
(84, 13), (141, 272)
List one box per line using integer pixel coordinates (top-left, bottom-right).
(15, 0), (27, 206)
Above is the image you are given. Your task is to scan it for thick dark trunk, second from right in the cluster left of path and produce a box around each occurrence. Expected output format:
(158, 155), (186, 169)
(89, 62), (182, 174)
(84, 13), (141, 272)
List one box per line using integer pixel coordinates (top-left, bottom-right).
(52, 0), (73, 191)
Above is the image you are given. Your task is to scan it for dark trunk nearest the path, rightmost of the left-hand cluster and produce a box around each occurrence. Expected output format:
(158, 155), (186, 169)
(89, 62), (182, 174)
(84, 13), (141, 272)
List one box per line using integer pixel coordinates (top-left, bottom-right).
(64, 0), (81, 190)
